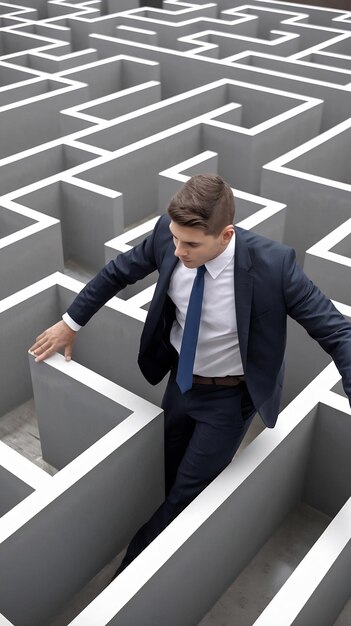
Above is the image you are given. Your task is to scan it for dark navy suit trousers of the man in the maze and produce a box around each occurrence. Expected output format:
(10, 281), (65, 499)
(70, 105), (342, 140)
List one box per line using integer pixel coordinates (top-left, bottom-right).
(117, 370), (255, 574)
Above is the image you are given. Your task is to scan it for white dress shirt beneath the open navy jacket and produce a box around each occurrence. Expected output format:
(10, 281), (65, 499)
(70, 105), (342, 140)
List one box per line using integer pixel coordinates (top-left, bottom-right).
(168, 235), (243, 376)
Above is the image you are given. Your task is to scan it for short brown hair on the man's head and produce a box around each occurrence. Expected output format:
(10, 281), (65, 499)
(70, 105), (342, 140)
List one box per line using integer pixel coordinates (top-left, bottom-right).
(167, 174), (235, 236)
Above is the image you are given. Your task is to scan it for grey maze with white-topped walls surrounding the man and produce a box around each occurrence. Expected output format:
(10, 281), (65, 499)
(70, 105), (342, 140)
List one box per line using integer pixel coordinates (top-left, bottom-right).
(0, 0), (351, 626)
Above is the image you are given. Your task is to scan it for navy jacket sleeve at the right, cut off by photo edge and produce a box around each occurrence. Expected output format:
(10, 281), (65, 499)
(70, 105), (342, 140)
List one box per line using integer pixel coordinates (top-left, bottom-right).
(282, 250), (351, 406)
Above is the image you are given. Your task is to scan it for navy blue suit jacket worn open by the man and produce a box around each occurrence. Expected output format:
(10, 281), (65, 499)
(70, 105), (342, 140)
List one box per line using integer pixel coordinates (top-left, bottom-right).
(68, 215), (351, 428)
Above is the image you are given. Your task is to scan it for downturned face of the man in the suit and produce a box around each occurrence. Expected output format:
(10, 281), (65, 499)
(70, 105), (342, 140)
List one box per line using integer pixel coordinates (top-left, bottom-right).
(169, 221), (234, 268)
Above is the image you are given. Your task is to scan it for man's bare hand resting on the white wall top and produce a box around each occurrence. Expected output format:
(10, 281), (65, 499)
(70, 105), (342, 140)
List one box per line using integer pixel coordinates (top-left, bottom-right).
(29, 320), (77, 363)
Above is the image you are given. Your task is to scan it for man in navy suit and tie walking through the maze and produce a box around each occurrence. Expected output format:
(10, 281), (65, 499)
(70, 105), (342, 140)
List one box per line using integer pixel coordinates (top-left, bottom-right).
(31, 174), (351, 572)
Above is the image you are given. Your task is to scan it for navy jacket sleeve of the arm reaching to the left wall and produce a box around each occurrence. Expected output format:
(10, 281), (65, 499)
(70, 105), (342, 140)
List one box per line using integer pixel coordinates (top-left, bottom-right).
(67, 218), (162, 326)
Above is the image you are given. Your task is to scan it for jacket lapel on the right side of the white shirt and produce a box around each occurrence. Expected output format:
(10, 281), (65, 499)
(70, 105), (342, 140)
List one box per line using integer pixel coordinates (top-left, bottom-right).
(234, 227), (253, 371)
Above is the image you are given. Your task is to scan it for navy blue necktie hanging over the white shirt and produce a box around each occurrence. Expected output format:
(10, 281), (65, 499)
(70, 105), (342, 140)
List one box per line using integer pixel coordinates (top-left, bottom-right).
(176, 265), (206, 393)
